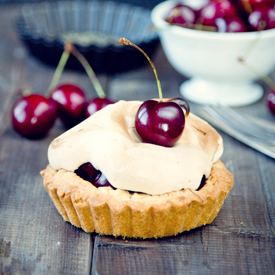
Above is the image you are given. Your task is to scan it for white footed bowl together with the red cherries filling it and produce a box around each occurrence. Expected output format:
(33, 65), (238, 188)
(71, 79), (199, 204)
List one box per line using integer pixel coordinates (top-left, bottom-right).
(151, 0), (275, 106)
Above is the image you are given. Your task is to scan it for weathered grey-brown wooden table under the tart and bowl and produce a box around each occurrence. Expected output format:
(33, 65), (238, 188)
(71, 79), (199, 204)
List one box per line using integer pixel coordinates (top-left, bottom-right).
(0, 6), (275, 275)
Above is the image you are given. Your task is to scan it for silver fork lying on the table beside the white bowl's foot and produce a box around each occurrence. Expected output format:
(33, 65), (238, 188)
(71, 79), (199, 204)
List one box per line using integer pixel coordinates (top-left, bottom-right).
(204, 103), (275, 146)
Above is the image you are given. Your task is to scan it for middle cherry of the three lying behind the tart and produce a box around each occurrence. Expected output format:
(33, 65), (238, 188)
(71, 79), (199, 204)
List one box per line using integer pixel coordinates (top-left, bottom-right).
(51, 84), (86, 128)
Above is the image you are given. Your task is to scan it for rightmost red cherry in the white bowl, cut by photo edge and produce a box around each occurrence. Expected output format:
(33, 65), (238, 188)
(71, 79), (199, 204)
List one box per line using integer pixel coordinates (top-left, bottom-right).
(248, 7), (275, 31)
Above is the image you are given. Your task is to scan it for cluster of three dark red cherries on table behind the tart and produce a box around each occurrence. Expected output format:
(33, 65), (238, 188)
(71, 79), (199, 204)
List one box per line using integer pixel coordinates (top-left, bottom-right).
(12, 84), (113, 139)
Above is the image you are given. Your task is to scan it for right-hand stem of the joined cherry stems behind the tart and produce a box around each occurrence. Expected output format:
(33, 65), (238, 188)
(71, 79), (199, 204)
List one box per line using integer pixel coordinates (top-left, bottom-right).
(71, 44), (106, 98)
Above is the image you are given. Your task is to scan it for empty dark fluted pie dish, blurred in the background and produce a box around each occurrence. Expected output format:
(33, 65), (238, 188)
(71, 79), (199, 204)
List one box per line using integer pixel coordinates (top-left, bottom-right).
(16, 1), (159, 74)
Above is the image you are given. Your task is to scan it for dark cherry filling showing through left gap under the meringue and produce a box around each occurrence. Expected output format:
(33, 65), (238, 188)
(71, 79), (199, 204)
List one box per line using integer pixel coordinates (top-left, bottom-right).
(74, 162), (112, 187)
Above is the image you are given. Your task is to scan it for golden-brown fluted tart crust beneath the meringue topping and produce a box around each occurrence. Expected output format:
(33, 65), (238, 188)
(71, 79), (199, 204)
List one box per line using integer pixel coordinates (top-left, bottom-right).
(41, 160), (233, 239)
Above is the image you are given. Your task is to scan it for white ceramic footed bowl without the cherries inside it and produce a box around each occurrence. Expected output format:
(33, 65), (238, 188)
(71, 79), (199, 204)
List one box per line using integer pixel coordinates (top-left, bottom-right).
(151, 1), (275, 106)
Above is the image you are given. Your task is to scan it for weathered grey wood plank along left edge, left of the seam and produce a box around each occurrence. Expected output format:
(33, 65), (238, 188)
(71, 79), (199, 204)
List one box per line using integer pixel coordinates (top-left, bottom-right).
(0, 4), (93, 274)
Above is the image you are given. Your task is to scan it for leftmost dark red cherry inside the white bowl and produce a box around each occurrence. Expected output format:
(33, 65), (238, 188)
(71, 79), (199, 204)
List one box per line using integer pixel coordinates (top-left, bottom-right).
(166, 4), (197, 28)
